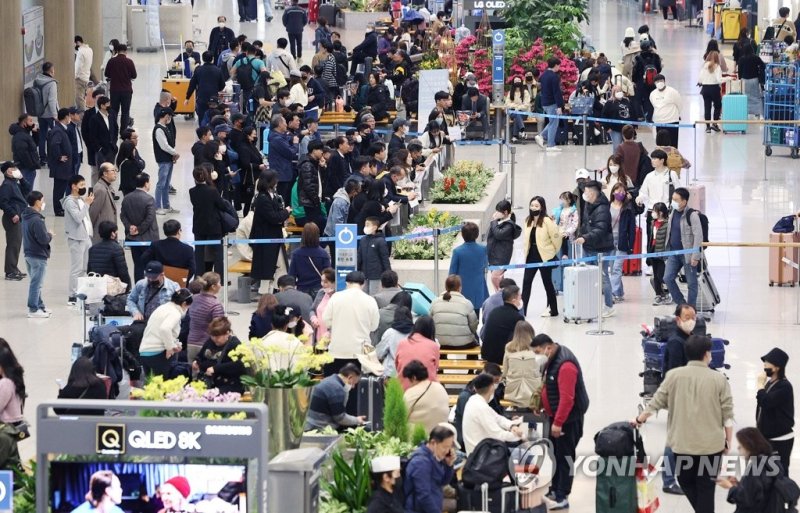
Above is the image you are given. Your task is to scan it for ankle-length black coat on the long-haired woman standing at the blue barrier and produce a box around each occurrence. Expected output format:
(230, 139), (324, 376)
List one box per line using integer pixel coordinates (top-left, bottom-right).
(250, 193), (289, 280)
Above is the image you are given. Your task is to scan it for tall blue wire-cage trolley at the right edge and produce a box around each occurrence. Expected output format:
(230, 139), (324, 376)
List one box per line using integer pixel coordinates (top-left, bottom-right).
(764, 62), (800, 159)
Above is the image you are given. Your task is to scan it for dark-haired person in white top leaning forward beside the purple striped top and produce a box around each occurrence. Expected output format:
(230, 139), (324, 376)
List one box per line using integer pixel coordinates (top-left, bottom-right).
(139, 289), (192, 377)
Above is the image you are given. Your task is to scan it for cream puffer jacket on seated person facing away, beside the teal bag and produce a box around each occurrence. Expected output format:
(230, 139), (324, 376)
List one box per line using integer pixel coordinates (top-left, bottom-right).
(431, 292), (478, 347)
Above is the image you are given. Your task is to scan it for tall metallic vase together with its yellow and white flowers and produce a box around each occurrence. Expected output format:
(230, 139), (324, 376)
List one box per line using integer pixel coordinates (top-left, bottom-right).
(230, 338), (333, 457)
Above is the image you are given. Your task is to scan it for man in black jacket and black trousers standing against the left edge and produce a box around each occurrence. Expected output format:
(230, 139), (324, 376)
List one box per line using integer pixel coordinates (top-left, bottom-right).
(0, 161), (31, 281)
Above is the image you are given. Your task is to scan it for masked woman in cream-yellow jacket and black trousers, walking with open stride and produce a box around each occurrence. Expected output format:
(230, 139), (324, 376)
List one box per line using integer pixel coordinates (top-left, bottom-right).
(520, 196), (563, 316)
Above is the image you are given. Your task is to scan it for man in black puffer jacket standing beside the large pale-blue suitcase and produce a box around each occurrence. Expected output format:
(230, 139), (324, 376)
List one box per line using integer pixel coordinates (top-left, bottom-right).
(575, 180), (615, 317)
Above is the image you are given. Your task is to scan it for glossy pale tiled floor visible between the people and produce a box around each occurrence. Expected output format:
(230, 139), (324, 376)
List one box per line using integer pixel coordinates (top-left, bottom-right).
(0, 0), (800, 506)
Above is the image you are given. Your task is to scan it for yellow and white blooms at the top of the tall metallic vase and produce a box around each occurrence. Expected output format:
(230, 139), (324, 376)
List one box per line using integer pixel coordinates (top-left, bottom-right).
(230, 337), (333, 388)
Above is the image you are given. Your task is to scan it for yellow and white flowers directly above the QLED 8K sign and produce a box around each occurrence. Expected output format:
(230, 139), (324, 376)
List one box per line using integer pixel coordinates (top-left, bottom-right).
(131, 376), (245, 420)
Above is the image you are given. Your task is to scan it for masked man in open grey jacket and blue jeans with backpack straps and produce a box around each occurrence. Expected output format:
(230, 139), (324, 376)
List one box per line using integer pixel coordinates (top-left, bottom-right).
(664, 187), (703, 306)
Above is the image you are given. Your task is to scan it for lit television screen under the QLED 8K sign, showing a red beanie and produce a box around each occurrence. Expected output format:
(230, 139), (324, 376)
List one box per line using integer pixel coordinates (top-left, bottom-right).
(49, 461), (248, 513)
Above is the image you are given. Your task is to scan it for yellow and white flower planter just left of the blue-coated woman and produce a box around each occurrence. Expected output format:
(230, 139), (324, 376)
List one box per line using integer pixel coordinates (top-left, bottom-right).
(392, 208), (462, 260)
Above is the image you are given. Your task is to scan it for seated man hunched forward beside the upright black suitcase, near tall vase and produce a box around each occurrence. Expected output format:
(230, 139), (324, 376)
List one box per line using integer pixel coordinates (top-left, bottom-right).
(305, 363), (364, 431)
